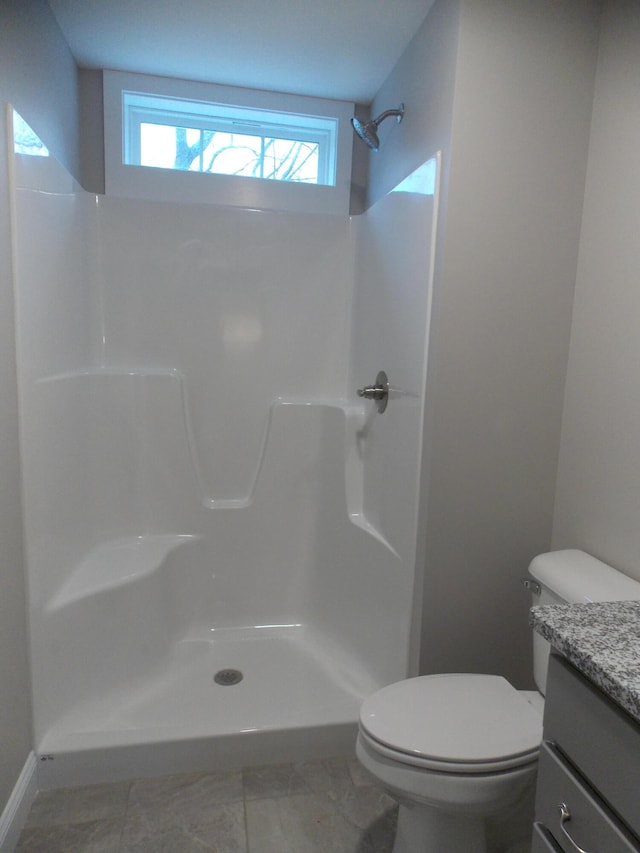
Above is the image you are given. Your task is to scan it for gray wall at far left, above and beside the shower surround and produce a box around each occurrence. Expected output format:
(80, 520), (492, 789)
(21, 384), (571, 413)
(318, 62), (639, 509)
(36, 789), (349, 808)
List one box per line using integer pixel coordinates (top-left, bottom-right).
(0, 0), (79, 811)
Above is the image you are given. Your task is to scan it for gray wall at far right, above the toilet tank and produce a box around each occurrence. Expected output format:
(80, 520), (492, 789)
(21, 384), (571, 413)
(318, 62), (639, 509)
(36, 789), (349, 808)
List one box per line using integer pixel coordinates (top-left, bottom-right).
(553, 0), (640, 580)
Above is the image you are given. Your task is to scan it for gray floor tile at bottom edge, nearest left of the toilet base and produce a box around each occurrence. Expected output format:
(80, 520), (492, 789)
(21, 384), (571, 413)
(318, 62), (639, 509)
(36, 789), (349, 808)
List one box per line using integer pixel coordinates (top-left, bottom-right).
(246, 794), (363, 853)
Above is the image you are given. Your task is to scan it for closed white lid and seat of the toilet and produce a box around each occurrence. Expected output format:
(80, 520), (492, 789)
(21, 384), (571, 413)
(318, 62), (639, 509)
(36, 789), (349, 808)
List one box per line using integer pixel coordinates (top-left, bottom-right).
(360, 674), (542, 772)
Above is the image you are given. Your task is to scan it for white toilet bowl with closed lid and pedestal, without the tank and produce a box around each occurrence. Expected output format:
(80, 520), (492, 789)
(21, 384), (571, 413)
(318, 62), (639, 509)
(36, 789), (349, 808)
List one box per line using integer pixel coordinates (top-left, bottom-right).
(356, 674), (542, 853)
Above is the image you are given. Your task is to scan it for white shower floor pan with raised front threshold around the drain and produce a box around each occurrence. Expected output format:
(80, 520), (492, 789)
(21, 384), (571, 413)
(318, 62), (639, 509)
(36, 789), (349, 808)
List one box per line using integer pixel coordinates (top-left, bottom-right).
(38, 626), (379, 789)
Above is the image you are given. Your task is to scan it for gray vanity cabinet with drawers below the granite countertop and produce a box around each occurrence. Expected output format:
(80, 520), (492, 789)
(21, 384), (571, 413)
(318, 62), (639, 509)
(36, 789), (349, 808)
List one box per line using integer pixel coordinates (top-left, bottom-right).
(531, 654), (640, 853)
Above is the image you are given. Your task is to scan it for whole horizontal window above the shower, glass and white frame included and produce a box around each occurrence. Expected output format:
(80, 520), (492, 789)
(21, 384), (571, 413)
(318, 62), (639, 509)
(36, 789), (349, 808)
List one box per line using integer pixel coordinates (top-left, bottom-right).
(105, 72), (353, 213)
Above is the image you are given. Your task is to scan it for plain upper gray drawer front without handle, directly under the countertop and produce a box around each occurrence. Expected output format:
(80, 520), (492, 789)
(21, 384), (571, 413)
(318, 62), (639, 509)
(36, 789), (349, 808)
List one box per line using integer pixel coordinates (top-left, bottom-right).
(544, 655), (640, 838)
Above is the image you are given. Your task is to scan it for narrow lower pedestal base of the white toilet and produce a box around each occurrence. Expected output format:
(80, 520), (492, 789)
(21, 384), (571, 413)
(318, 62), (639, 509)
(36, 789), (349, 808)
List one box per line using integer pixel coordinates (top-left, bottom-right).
(393, 804), (487, 853)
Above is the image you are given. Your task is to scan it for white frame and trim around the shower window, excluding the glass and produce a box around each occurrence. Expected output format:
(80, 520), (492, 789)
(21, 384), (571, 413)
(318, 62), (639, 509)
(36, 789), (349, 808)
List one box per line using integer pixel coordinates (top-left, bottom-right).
(103, 71), (353, 214)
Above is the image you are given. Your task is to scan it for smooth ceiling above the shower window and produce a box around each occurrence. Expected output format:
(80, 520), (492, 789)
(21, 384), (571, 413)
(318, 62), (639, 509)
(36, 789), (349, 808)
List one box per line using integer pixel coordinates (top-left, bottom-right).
(49, 0), (433, 104)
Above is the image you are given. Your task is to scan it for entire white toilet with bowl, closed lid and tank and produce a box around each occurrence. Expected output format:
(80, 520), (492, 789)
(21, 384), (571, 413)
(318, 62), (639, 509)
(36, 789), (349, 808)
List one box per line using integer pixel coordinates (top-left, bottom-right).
(356, 550), (640, 853)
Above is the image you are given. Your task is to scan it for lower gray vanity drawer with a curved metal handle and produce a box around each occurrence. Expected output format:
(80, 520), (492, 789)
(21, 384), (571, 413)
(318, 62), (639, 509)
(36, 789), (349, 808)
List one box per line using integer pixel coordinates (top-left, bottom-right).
(536, 743), (640, 853)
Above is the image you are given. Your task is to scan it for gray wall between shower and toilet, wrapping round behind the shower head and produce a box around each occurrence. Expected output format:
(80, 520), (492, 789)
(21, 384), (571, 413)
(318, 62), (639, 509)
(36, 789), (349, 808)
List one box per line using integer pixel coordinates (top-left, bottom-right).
(370, 0), (599, 685)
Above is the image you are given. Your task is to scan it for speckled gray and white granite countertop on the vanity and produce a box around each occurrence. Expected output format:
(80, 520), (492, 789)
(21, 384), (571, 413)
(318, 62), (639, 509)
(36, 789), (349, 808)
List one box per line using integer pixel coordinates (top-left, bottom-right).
(529, 601), (640, 722)
